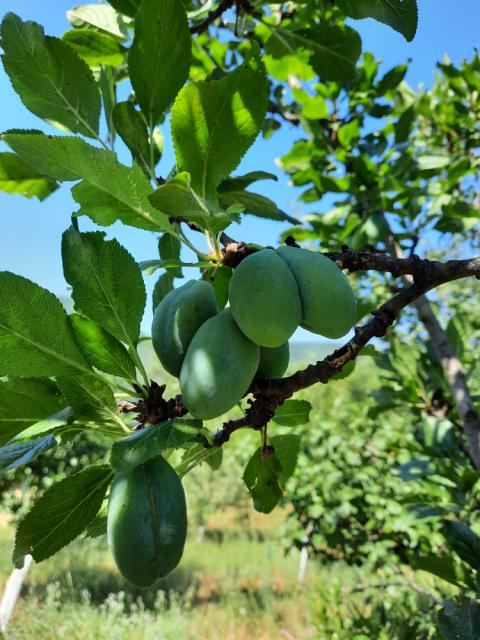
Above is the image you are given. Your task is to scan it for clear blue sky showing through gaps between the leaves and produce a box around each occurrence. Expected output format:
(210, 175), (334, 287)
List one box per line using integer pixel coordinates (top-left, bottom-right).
(0, 0), (480, 339)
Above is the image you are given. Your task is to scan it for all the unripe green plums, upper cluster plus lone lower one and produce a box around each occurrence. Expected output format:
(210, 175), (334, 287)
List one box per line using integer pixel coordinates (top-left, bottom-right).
(107, 246), (356, 587)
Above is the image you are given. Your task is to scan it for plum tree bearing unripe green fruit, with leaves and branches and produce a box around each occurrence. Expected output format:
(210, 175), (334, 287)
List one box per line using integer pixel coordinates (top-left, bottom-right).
(0, 0), (480, 636)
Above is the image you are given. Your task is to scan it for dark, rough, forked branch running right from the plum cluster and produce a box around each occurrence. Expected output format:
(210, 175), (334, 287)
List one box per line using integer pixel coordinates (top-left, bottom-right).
(135, 245), (480, 446)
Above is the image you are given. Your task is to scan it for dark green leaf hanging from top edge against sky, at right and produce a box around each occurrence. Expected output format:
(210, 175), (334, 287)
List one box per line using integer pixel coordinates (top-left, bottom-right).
(337, 0), (418, 41)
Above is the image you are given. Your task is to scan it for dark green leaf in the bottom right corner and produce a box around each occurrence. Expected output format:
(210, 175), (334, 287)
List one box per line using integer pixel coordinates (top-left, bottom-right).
(438, 595), (480, 640)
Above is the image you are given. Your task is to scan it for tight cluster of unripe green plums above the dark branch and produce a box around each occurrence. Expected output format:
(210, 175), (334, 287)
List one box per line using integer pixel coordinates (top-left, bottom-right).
(152, 246), (356, 420)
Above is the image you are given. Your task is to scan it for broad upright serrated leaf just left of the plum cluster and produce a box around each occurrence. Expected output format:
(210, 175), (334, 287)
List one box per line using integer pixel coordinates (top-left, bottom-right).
(62, 227), (146, 345)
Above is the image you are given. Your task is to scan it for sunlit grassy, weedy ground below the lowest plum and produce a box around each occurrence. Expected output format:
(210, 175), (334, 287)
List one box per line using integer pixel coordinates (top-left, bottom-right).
(0, 514), (433, 640)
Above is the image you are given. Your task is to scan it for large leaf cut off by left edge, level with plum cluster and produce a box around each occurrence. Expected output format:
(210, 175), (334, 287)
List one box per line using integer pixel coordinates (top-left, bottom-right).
(0, 271), (89, 378)
